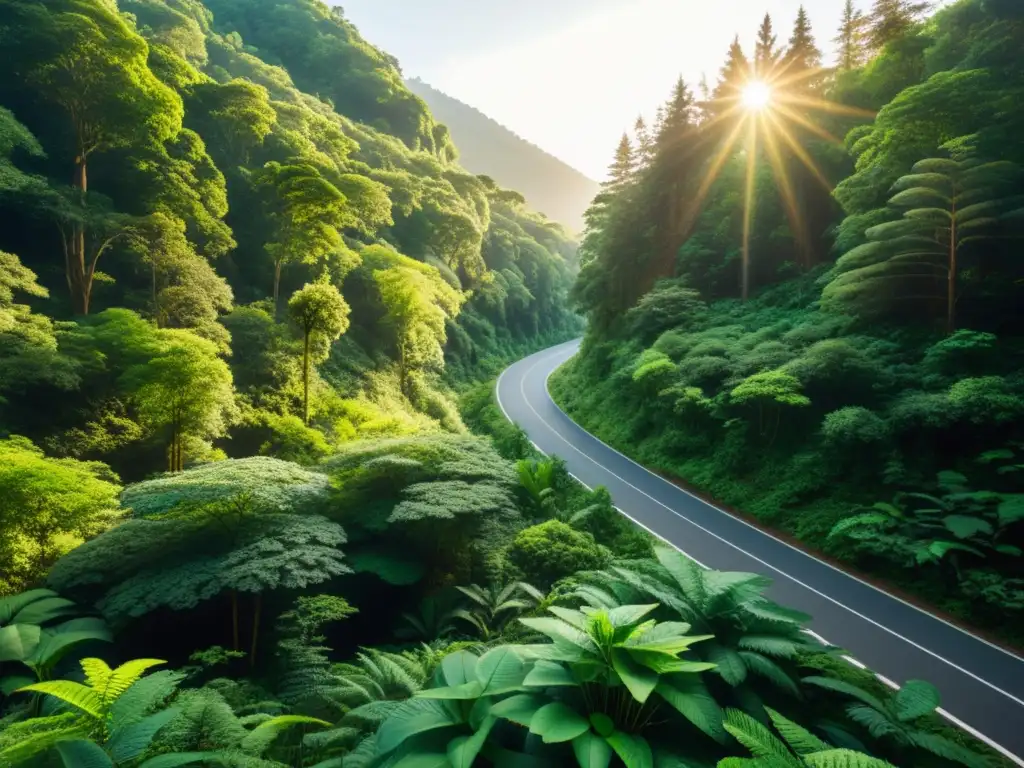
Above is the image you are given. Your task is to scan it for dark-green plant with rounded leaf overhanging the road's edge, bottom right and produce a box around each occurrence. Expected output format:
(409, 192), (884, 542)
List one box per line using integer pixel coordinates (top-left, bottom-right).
(804, 676), (988, 768)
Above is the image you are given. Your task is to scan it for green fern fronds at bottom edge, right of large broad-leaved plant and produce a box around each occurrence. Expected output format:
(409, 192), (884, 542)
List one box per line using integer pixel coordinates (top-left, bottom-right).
(718, 709), (894, 768)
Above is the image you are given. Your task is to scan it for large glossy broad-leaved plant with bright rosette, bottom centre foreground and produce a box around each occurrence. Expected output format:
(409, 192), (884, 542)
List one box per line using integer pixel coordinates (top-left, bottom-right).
(366, 605), (727, 768)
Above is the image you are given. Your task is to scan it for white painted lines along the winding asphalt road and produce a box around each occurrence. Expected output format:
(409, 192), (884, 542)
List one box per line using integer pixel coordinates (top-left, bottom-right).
(495, 350), (1024, 766)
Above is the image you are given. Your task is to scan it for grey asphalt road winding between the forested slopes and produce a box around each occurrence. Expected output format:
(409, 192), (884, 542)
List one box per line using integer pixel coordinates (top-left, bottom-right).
(497, 341), (1024, 766)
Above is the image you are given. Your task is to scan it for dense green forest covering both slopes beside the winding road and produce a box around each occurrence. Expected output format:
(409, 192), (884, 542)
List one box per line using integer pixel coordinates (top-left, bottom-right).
(0, 0), (1024, 768)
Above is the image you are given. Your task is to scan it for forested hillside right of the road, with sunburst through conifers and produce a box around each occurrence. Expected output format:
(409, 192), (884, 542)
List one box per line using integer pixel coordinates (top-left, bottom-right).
(552, 0), (1024, 645)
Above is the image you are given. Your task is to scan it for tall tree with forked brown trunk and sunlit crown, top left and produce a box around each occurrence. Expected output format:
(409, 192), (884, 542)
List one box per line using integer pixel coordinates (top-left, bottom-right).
(0, 0), (183, 314)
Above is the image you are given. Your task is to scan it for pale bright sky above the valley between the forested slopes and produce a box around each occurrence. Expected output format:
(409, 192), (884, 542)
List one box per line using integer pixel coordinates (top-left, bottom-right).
(341, 0), (851, 180)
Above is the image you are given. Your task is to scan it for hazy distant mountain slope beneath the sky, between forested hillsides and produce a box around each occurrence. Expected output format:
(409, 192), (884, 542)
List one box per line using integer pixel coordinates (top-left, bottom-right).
(406, 79), (600, 233)
